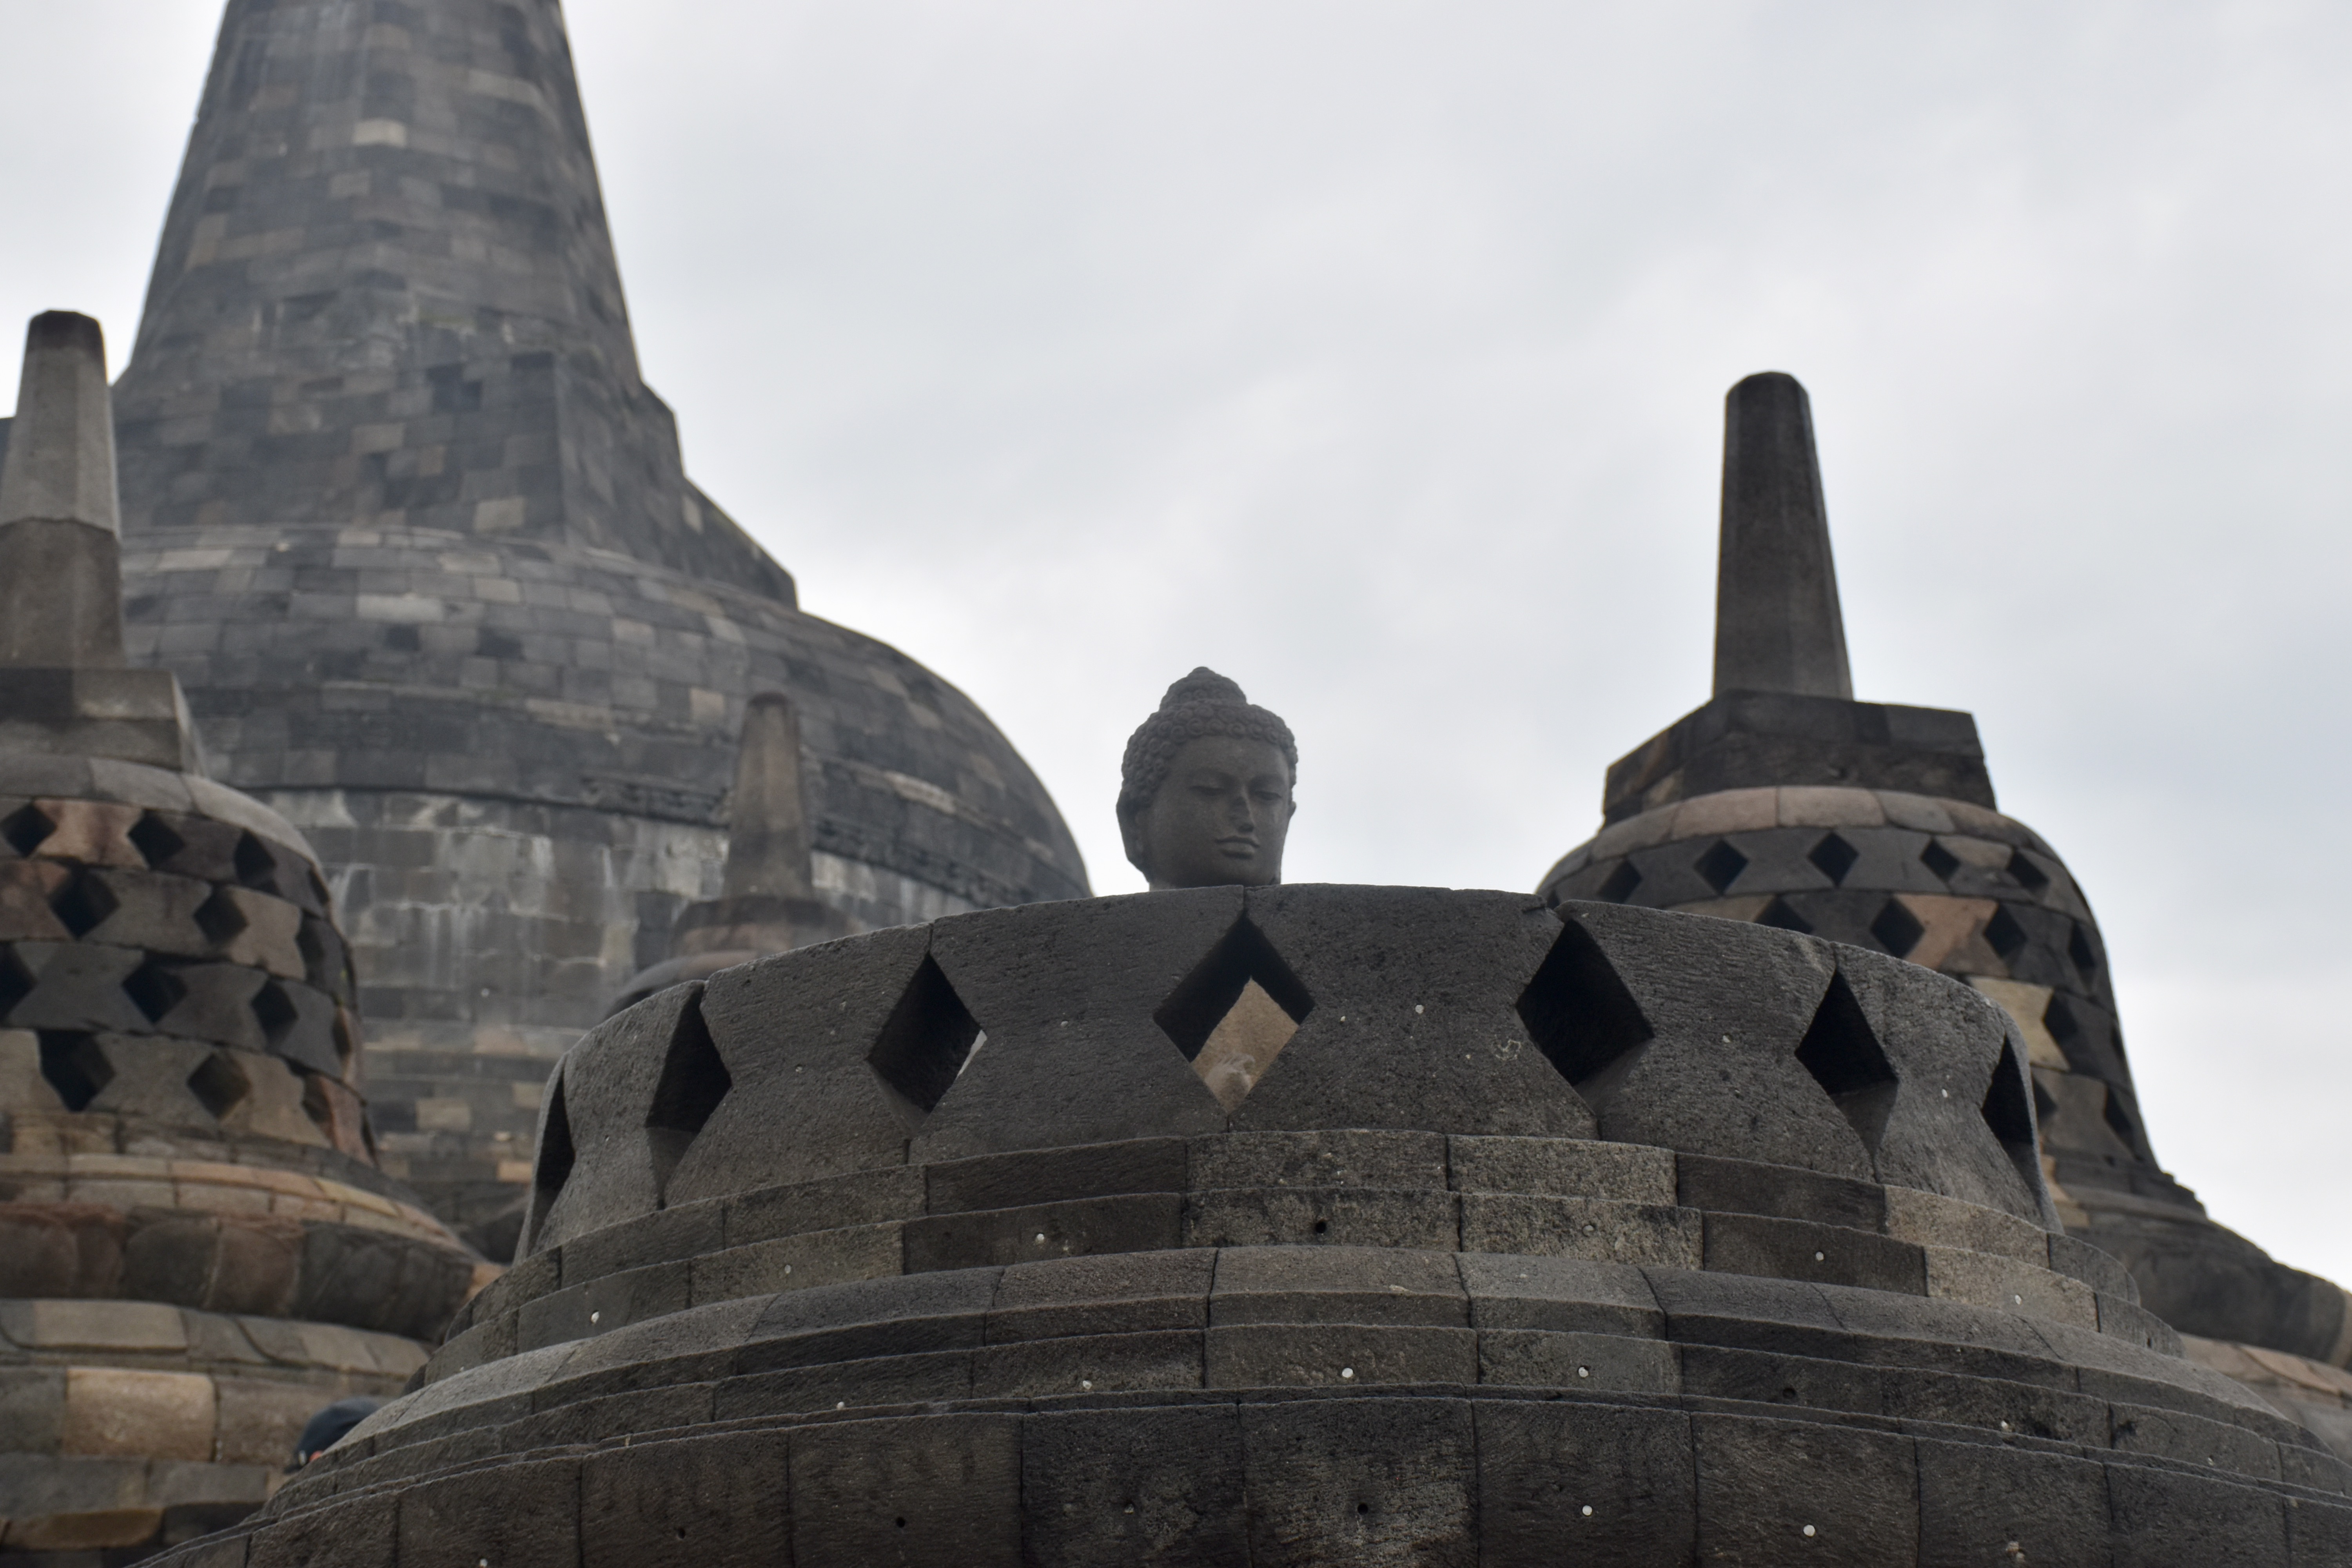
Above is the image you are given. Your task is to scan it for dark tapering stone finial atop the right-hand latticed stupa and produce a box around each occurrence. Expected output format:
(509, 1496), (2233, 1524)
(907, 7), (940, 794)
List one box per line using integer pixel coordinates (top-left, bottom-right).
(1715, 372), (1853, 701)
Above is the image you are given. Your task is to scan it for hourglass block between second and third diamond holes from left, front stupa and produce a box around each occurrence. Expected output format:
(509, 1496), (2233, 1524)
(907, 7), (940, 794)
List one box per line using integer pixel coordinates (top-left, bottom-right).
(670, 926), (931, 1225)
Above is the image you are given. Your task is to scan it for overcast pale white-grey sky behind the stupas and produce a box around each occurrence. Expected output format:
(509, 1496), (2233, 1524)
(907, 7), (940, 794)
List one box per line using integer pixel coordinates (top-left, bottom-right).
(0, 0), (2352, 1281)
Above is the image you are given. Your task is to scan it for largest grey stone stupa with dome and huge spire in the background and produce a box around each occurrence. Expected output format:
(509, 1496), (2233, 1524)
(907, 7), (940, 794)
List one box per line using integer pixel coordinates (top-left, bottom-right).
(115, 0), (1087, 1246)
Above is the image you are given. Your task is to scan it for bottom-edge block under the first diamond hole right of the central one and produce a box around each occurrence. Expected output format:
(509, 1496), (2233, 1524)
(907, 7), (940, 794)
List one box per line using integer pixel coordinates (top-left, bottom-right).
(1477, 1399), (1696, 1568)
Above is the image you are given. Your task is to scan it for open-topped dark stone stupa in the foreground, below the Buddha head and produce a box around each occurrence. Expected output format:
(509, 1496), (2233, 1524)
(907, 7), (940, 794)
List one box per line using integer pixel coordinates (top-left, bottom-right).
(142, 886), (2352, 1568)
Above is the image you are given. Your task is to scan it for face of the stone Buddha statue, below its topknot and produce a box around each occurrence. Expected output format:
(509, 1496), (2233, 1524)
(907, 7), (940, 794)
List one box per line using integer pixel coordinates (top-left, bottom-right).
(1122, 736), (1296, 889)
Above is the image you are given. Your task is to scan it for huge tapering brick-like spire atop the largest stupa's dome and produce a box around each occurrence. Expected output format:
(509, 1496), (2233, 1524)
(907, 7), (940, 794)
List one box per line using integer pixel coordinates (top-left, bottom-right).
(115, 0), (793, 602)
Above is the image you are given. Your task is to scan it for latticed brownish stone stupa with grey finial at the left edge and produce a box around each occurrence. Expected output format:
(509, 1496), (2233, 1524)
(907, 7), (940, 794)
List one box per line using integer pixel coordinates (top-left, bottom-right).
(0, 313), (492, 1568)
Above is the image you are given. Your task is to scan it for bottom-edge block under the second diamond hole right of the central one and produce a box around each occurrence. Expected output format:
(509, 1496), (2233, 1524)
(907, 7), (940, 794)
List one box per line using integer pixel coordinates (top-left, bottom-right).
(1691, 1415), (1919, 1568)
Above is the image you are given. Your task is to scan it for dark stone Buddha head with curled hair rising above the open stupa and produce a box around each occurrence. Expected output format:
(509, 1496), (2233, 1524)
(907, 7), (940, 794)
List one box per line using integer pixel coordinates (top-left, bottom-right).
(1120, 668), (1298, 891)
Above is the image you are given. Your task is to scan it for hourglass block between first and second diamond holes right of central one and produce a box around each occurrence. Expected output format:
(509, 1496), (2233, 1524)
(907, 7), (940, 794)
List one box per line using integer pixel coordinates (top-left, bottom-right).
(1562, 905), (1870, 1178)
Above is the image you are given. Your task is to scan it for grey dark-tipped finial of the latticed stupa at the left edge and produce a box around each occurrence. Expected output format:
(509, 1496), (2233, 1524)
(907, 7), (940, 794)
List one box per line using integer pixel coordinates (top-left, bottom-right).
(0, 310), (122, 670)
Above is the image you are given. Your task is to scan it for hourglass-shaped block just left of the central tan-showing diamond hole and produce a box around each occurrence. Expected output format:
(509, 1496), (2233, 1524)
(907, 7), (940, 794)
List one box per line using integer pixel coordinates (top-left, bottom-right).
(915, 889), (1251, 1159)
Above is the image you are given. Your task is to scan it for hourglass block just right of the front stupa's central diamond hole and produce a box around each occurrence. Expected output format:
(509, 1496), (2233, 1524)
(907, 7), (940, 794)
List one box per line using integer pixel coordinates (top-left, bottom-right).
(1232, 886), (1592, 1138)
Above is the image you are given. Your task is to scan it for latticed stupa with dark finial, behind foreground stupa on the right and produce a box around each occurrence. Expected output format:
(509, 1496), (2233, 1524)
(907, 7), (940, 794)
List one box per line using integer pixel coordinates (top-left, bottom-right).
(1543, 374), (2352, 1455)
